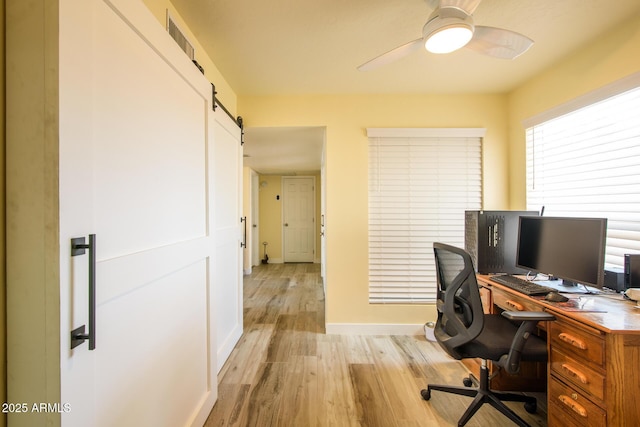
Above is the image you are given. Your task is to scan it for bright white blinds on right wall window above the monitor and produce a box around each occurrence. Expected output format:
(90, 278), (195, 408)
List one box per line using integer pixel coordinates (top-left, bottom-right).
(527, 84), (640, 266)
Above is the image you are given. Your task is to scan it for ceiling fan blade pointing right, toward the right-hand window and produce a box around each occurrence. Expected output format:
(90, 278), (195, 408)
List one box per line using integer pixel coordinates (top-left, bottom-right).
(465, 25), (533, 59)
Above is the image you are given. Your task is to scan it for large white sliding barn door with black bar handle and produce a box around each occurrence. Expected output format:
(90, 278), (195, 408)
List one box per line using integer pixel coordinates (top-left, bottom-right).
(60, 0), (229, 426)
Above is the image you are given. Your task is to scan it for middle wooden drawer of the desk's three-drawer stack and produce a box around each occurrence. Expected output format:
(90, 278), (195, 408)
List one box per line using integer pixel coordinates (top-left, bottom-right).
(550, 347), (605, 401)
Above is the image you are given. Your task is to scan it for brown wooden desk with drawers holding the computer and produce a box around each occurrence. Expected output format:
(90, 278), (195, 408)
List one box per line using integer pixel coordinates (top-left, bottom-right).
(478, 275), (640, 426)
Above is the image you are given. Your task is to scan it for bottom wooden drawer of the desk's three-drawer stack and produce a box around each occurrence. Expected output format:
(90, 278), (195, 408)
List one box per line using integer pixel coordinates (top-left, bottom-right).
(549, 375), (607, 427)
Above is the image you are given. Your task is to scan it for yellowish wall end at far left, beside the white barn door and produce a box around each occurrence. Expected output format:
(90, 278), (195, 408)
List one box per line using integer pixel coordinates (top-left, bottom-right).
(5, 0), (61, 426)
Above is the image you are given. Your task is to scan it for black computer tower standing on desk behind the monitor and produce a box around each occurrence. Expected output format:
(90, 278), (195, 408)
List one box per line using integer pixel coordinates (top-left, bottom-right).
(464, 211), (538, 274)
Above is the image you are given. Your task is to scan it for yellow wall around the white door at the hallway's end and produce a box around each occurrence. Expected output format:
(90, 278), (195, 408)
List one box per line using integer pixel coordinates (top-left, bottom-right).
(258, 172), (321, 262)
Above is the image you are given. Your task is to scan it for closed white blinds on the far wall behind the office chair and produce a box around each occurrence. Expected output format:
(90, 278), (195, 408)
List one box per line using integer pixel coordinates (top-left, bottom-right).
(367, 129), (484, 303)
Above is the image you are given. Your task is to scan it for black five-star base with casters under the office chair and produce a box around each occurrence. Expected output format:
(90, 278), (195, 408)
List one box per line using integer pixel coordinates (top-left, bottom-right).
(420, 360), (538, 427)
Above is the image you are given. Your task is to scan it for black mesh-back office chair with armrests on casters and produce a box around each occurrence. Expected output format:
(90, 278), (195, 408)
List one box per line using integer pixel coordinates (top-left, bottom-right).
(421, 243), (555, 426)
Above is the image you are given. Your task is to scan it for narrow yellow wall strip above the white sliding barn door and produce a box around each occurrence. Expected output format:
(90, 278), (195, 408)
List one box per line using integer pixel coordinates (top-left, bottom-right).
(143, 0), (238, 116)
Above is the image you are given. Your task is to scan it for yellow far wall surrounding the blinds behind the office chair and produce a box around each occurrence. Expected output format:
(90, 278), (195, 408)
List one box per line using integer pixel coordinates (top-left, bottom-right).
(238, 95), (508, 324)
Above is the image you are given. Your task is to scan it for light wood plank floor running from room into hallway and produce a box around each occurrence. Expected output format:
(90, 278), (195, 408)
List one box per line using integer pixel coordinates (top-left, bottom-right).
(205, 264), (546, 427)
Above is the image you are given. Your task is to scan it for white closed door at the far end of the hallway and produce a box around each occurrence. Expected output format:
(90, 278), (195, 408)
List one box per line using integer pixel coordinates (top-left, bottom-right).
(283, 177), (316, 262)
